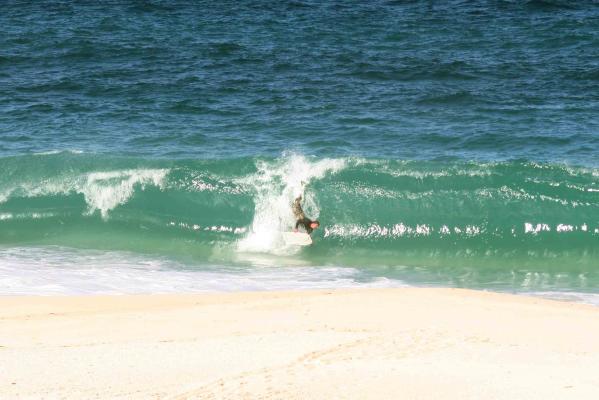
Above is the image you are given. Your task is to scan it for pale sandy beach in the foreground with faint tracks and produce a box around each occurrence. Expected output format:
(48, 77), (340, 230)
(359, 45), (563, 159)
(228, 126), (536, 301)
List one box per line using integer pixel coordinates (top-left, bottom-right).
(0, 289), (599, 400)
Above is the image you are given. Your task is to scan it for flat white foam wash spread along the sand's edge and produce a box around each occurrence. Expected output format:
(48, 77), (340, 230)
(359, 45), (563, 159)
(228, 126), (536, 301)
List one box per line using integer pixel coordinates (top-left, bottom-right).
(0, 247), (404, 295)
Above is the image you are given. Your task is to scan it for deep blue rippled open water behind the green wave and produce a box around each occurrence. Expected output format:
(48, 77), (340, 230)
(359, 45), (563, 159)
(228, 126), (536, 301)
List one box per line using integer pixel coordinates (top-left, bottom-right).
(0, 1), (599, 162)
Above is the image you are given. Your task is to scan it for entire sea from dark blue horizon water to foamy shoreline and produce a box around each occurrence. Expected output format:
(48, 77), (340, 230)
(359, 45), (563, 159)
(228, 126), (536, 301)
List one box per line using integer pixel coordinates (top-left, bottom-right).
(0, 1), (599, 301)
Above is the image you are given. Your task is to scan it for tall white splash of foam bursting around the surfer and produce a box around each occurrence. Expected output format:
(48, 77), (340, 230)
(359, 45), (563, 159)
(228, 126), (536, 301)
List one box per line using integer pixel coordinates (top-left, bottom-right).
(238, 154), (345, 254)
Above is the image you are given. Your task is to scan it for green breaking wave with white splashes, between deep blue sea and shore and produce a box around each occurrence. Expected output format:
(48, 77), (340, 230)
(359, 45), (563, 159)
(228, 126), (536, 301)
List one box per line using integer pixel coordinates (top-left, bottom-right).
(0, 153), (599, 296)
